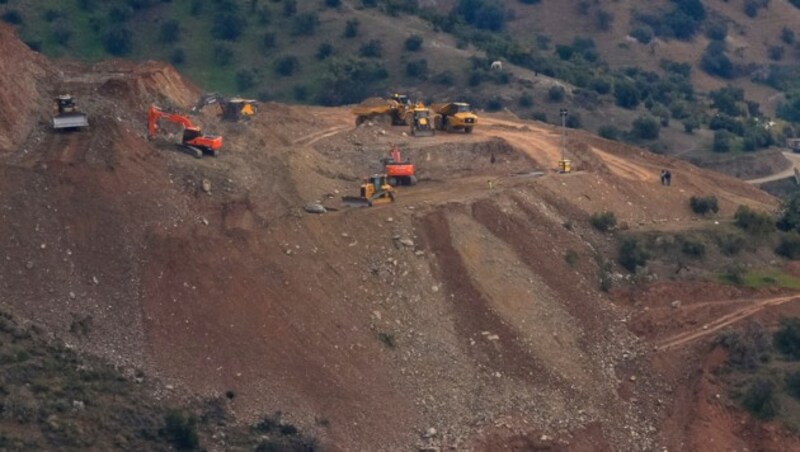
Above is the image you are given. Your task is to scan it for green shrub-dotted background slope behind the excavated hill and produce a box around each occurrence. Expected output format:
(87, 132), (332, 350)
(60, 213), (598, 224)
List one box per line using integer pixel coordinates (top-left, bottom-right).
(0, 0), (800, 153)
